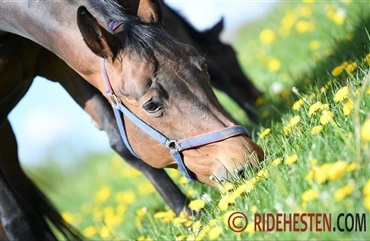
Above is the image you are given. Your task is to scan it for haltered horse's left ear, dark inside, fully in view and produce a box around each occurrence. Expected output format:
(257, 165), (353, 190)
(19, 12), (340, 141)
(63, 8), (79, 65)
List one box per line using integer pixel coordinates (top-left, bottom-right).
(77, 6), (117, 61)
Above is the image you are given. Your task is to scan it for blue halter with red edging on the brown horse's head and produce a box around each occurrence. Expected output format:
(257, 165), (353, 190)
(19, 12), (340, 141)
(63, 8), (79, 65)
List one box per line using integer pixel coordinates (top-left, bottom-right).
(100, 21), (250, 183)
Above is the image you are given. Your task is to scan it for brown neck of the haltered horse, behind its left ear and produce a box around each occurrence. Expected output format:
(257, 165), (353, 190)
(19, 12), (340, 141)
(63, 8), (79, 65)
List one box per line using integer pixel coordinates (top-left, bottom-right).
(0, 1), (104, 89)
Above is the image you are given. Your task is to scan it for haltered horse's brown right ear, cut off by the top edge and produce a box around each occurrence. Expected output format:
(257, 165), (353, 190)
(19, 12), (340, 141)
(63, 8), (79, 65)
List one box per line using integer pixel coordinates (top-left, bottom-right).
(137, 0), (162, 25)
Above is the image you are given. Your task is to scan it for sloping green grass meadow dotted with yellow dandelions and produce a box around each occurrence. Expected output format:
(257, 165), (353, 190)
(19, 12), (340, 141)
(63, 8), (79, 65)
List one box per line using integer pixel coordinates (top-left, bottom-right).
(24, 0), (370, 240)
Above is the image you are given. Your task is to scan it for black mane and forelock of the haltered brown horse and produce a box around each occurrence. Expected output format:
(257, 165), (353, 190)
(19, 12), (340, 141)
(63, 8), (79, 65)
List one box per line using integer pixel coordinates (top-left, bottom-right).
(89, 0), (181, 60)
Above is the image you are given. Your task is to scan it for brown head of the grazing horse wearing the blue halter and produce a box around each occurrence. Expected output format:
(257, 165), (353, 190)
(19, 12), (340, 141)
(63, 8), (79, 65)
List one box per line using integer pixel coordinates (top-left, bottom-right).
(77, 0), (263, 186)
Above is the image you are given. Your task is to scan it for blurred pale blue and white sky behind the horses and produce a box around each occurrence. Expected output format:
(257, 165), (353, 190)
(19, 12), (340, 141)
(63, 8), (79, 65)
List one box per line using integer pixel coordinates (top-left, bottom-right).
(7, 0), (275, 165)
